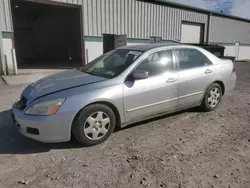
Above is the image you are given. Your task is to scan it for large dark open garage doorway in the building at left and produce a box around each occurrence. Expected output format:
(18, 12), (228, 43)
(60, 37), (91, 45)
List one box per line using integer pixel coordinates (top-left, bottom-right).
(11, 0), (82, 69)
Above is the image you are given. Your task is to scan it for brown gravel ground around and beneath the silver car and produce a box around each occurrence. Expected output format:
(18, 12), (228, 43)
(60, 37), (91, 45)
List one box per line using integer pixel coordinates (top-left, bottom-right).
(0, 62), (250, 188)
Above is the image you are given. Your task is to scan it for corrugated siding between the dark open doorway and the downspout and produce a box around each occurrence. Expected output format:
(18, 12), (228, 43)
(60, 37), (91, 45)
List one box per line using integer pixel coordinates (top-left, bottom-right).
(83, 0), (208, 40)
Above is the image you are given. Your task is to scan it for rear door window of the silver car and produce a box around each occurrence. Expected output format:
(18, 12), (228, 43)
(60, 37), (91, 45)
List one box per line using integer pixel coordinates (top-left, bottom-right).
(175, 49), (204, 70)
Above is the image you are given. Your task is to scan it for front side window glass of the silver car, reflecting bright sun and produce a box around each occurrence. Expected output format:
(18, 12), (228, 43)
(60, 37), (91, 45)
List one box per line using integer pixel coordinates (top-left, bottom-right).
(136, 50), (173, 76)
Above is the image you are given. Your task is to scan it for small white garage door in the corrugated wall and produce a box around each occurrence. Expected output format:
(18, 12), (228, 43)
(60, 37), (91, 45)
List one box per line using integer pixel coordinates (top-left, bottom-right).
(181, 24), (201, 44)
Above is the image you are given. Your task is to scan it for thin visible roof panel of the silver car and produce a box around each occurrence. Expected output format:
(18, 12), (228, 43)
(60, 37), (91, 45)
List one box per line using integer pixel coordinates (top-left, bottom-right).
(119, 43), (188, 52)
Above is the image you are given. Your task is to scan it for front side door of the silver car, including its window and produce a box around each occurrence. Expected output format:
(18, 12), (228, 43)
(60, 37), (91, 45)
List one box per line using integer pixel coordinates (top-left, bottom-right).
(123, 50), (178, 122)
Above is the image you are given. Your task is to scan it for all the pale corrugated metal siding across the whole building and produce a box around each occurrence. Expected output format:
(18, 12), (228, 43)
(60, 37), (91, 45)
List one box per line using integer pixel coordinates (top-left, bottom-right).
(0, 0), (250, 44)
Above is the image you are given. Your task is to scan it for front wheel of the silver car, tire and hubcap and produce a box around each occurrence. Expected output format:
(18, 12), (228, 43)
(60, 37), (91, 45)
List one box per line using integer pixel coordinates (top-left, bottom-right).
(72, 104), (116, 146)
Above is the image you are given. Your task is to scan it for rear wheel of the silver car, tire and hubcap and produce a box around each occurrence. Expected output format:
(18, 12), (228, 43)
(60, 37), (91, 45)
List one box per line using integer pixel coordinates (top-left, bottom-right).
(201, 83), (222, 112)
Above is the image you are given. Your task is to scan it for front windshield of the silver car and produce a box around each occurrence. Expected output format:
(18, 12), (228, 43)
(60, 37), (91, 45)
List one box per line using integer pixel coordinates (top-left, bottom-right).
(82, 49), (142, 78)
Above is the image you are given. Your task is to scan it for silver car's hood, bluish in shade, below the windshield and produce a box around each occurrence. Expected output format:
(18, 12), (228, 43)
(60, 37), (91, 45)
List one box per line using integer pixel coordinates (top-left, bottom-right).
(23, 69), (107, 101)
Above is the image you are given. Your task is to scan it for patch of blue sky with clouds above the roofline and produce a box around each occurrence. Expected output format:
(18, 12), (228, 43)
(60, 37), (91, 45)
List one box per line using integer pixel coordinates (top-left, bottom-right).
(169, 0), (250, 19)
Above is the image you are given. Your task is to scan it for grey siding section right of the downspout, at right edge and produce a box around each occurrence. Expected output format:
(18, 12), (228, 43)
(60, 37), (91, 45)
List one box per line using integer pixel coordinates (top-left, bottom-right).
(209, 16), (250, 44)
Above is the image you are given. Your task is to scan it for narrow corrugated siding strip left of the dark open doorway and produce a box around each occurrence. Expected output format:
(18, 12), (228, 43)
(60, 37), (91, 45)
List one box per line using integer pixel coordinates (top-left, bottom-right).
(0, 0), (13, 31)
